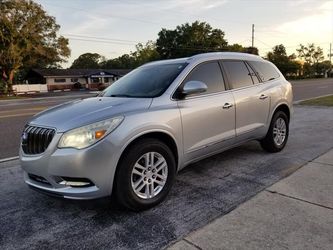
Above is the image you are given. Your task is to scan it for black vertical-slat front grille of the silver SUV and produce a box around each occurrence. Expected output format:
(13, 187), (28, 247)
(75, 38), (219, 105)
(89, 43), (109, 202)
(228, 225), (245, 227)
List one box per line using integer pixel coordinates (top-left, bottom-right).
(22, 126), (55, 155)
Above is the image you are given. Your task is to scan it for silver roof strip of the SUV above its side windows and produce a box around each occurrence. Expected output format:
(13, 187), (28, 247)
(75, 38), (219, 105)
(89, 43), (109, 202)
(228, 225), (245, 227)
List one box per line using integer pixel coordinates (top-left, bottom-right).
(144, 52), (265, 66)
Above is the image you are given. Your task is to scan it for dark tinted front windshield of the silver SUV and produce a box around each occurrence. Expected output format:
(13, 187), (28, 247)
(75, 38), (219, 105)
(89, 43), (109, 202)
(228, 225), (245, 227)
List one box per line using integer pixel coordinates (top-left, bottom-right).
(100, 63), (187, 98)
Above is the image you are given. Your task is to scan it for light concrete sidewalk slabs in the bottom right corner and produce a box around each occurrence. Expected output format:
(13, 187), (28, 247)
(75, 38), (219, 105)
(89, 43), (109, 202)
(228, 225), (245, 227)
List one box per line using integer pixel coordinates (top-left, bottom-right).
(168, 149), (333, 250)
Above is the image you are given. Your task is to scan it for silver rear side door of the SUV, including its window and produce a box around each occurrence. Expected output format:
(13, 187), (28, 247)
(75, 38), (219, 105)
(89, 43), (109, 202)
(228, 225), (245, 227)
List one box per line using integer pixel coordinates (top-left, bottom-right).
(222, 60), (270, 138)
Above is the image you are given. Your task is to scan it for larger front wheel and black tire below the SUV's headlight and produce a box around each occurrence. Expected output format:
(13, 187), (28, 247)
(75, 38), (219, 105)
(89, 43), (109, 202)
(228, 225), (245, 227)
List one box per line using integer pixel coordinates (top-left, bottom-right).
(115, 139), (176, 211)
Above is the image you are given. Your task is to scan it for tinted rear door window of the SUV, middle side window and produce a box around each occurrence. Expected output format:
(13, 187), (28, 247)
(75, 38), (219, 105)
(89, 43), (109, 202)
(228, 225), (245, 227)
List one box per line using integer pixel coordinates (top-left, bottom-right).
(223, 61), (253, 89)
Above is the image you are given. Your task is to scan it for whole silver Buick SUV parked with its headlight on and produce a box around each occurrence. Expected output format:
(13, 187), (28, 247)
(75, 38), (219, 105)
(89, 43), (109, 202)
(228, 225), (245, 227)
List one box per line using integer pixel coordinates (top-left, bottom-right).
(20, 53), (292, 210)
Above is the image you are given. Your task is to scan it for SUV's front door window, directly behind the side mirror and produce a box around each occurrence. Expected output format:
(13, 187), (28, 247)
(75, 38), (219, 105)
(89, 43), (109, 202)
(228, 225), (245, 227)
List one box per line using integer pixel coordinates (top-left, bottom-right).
(185, 61), (225, 94)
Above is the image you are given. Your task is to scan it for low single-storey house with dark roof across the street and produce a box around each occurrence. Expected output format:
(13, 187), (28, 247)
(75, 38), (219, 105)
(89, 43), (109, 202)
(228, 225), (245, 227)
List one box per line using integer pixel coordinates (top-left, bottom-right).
(26, 69), (130, 91)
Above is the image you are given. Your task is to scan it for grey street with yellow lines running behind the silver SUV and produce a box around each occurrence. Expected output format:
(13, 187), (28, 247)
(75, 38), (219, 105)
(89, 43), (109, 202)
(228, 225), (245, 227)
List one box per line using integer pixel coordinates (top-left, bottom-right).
(0, 78), (333, 160)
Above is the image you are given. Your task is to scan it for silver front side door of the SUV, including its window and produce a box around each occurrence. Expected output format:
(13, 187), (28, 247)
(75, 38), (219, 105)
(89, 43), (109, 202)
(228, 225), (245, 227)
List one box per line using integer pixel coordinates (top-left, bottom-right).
(178, 61), (235, 160)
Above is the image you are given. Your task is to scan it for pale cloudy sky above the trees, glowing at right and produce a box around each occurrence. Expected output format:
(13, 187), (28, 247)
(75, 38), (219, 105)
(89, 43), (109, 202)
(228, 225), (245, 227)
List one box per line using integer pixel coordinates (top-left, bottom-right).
(35, 0), (333, 67)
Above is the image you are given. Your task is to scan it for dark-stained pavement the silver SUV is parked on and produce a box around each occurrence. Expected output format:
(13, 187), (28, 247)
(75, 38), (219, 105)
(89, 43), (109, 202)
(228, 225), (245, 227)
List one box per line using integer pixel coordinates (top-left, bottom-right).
(0, 106), (333, 249)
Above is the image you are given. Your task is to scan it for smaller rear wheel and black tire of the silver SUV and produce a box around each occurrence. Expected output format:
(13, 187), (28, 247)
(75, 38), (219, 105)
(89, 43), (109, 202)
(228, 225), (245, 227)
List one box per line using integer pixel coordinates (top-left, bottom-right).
(260, 111), (289, 153)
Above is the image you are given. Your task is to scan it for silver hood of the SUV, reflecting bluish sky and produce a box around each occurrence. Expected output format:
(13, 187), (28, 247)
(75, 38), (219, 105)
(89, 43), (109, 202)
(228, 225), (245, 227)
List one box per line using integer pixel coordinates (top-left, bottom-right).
(29, 97), (152, 132)
